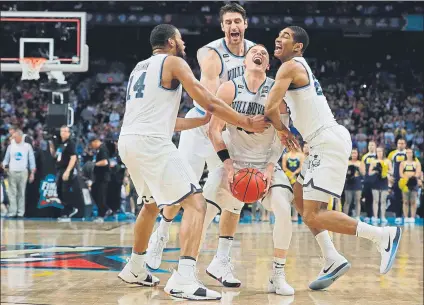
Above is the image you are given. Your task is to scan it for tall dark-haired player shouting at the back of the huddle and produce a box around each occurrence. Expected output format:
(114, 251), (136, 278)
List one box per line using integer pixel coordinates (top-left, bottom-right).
(144, 3), (254, 269)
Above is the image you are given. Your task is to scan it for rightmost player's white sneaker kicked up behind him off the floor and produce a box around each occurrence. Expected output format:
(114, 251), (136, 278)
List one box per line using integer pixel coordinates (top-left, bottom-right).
(377, 227), (402, 274)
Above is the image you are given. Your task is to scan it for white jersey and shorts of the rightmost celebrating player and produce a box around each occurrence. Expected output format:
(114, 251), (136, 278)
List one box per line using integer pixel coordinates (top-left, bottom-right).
(290, 57), (352, 202)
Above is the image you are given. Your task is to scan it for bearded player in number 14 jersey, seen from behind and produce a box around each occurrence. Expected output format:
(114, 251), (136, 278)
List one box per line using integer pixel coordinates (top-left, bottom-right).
(118, 24), (268, 300)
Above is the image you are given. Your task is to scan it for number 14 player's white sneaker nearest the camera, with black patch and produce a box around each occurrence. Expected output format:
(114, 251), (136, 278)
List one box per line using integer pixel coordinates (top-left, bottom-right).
(164, 270), (221, 301)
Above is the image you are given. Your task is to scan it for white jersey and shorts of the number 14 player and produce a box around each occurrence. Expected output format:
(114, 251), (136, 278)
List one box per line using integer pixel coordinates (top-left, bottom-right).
(118, 54), (202, 207)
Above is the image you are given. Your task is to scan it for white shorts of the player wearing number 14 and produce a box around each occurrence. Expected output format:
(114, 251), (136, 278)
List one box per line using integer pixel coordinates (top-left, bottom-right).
(118, 135), (202, 208)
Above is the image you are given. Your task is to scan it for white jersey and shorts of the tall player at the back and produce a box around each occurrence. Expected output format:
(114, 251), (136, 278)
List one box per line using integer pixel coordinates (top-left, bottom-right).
(178, 38), (255, 180)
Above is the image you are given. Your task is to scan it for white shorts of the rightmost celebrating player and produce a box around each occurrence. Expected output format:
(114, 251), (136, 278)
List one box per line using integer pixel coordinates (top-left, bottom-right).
(297, 125), (352, 202)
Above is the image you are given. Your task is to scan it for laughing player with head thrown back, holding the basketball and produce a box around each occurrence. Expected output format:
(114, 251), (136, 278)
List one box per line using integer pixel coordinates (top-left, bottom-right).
(202, 45), (294, 295)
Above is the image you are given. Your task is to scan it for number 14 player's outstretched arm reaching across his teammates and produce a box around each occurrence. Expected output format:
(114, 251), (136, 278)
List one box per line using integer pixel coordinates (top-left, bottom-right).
(164, 56), (269, 132)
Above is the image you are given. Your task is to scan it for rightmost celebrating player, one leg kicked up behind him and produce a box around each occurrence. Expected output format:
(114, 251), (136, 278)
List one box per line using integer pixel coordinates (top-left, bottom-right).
(265, 26), (401, 280)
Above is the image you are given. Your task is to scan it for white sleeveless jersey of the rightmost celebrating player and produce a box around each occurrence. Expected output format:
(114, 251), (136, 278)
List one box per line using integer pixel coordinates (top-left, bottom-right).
(284, 57), (336, 141)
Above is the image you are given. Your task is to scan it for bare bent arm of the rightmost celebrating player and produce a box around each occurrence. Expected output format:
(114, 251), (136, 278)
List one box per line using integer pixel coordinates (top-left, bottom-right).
(265, 61), (296, 131)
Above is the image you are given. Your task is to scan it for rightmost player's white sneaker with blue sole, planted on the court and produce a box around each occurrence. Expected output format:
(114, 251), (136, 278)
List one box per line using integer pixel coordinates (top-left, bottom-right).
(309, 255), (350, 290)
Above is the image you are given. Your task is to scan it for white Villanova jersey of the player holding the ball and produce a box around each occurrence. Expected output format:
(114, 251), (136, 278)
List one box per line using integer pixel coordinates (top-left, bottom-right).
(223, 76), (277, 163)
